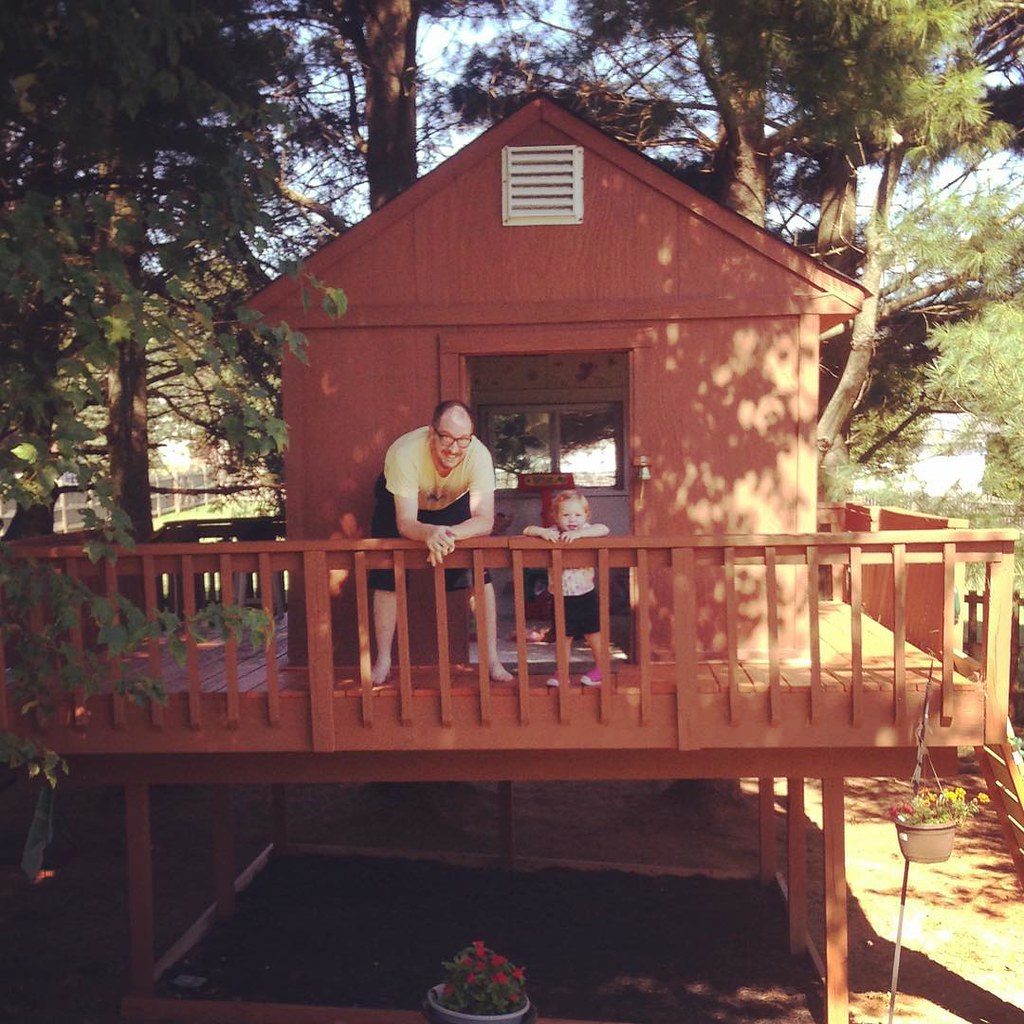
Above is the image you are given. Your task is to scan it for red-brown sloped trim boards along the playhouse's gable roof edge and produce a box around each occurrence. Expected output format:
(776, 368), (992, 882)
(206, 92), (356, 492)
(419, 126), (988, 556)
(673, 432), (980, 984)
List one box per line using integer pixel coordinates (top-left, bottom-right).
(249, 96), (870, 316)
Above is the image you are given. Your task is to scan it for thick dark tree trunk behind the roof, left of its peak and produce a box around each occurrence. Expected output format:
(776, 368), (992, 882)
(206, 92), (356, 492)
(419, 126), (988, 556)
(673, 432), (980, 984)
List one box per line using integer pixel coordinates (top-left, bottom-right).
(360, 0), (419, 210)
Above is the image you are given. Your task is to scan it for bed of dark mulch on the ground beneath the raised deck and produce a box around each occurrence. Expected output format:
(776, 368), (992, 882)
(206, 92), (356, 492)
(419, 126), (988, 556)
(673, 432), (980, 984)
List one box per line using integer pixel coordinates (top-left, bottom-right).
(162, 856), (819, 1024)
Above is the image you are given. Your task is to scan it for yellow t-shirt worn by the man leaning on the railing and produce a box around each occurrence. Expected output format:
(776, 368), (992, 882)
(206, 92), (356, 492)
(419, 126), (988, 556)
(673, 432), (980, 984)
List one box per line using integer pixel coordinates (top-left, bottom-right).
(384, 427), (495, 511)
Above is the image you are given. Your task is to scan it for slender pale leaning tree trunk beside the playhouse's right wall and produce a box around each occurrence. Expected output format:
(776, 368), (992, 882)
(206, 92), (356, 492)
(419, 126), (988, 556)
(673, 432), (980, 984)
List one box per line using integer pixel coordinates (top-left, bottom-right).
(818, 145), (904, 496)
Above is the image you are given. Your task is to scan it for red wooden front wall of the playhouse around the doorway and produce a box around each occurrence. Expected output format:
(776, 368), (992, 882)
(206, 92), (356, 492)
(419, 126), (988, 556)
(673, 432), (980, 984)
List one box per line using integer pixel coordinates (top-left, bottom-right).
(276, 112), (818, 664)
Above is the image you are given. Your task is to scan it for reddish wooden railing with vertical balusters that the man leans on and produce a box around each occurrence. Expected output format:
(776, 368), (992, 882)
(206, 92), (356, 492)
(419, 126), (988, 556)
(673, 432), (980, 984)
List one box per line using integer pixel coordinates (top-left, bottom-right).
(0, 529), (1016, 751)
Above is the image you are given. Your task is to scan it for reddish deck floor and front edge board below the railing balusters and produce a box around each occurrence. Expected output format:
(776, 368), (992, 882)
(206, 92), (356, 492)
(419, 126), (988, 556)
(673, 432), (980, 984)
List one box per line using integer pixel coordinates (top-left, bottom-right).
(12, 602), (986, 756)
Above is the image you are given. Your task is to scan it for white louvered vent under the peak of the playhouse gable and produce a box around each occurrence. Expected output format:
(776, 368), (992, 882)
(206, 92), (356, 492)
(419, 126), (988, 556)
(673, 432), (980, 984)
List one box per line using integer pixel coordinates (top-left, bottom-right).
(502, 145), (583, 225)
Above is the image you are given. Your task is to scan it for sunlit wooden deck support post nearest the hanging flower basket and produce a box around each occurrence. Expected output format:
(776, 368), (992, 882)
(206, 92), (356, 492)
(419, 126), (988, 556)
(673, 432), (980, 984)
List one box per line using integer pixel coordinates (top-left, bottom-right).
(821, 776), (850, 1024)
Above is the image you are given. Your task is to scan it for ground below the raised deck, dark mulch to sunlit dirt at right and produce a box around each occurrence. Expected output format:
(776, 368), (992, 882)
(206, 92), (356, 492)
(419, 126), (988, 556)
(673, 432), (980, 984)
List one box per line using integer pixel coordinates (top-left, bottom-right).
(0, 780), (1024, 1024)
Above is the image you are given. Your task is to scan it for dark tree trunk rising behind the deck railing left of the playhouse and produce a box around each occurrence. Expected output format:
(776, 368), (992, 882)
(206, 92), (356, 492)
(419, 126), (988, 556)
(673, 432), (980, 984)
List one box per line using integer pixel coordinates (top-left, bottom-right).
(106, 340), (153, 541)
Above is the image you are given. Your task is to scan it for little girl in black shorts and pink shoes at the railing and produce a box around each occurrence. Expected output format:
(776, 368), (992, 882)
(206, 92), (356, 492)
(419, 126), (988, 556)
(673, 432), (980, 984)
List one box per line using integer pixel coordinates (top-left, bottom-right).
(523, 490), (608, 686)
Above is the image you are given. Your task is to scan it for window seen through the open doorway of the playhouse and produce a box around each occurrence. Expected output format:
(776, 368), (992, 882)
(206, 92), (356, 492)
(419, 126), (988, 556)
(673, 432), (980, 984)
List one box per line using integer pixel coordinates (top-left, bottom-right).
(480, 401), (623, 488)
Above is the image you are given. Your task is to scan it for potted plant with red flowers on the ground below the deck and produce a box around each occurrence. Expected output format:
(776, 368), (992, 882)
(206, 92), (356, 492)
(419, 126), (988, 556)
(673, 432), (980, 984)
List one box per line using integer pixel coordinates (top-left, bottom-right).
(427, 939), (530, 1024)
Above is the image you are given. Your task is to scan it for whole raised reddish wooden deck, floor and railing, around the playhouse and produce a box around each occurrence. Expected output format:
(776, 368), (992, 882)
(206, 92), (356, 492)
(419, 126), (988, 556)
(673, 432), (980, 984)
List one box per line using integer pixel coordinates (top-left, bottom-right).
(6, 530), (1013, 761)
